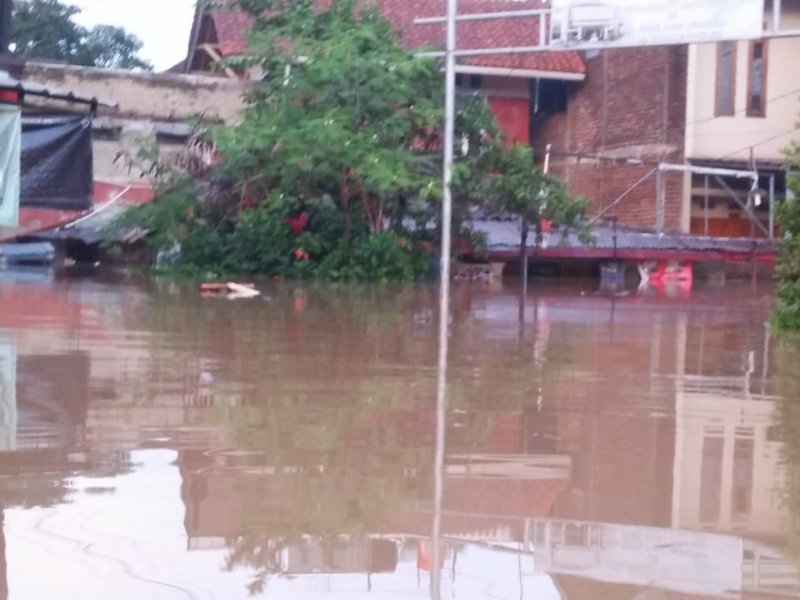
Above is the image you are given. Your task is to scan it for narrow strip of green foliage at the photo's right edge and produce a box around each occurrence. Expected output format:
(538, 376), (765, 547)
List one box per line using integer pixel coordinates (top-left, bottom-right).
(775, 142), (800, 329)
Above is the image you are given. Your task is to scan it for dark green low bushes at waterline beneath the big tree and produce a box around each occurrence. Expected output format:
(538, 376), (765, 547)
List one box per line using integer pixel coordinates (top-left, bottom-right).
(111, 185), (430, 282)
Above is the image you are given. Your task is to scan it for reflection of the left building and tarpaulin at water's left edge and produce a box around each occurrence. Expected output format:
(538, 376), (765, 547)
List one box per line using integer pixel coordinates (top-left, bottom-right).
(0, 335), (130, 599)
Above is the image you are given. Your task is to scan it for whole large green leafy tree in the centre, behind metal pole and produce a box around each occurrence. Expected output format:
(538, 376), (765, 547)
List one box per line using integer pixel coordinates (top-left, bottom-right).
(114, 0), (583, 280)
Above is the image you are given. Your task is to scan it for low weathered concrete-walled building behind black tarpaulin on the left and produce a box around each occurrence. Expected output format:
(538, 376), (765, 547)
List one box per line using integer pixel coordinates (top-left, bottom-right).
(0, 61), (252, 239)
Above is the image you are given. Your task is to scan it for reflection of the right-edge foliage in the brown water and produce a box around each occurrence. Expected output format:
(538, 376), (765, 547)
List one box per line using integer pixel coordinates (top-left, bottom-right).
(772, 335), (800, 559)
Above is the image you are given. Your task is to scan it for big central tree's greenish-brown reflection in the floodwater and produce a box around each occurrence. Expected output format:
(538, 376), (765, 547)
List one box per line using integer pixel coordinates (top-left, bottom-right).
(139, 285), (580, 592)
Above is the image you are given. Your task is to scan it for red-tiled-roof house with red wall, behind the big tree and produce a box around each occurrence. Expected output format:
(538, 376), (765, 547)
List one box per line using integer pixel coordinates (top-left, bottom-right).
(184, 0), (586, 148)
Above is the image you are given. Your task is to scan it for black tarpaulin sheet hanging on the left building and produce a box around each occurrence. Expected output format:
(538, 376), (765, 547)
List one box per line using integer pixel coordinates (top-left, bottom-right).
(20, 115), (93, 210)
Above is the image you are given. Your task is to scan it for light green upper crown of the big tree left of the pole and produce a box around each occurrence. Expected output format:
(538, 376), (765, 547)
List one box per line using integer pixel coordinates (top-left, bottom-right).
(220, 0), (450, 235)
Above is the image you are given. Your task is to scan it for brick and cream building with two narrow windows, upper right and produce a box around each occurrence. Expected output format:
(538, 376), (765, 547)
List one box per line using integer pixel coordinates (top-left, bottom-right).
(535, 0), (800, 238)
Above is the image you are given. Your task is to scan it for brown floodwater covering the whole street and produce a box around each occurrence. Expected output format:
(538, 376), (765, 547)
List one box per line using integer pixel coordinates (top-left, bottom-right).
(0, 272), (800, 600)
